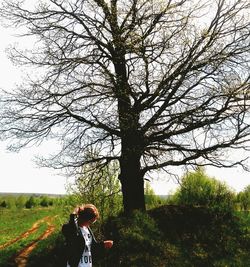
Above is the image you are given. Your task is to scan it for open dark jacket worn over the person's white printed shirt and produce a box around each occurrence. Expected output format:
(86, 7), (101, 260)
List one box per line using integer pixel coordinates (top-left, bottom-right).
(62, 214), (104, 267)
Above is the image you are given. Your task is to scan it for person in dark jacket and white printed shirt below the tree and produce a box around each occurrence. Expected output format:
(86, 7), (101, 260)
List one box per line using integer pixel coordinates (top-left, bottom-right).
(62, 204), (113, 267)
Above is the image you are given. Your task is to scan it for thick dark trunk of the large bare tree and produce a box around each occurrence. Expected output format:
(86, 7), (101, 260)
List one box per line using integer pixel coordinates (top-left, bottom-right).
(113, 49), (146, 214)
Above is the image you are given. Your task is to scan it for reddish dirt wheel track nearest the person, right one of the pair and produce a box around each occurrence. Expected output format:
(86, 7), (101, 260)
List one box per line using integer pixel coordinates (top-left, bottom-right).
(15, 217), (55, 267)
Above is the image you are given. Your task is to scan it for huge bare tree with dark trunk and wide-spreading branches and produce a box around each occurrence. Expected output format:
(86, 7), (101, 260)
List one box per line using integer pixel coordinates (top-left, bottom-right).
(0, 0), (250, 212)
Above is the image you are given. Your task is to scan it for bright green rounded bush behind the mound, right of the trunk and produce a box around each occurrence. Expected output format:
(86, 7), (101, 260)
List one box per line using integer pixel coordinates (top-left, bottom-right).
(173, 168), (236, 211)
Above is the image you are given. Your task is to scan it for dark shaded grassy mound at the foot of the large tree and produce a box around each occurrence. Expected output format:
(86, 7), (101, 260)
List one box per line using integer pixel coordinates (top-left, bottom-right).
(98, 205), (250, 267)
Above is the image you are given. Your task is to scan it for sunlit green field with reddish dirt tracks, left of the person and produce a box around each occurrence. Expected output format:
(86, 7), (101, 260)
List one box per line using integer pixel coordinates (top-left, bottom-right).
(0, 208), (65, 267)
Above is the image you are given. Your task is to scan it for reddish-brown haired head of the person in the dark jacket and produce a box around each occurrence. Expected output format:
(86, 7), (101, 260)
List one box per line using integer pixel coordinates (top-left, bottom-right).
(78, 204), (99, 224)
